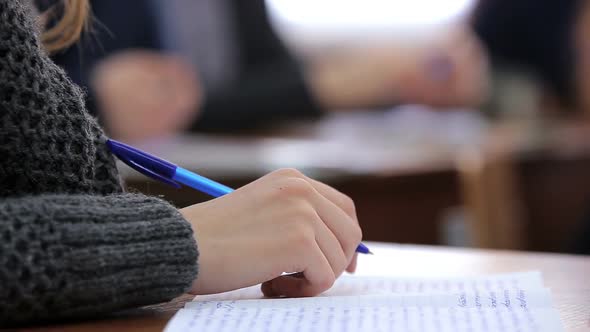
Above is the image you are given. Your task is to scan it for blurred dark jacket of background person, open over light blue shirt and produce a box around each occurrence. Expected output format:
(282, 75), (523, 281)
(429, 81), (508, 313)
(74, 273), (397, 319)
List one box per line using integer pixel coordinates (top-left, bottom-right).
(54, 0), (321, 130)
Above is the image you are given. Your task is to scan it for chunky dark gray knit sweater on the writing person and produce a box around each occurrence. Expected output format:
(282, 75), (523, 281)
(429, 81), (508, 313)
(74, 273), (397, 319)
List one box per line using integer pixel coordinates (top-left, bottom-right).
(0, 0), (198, 326)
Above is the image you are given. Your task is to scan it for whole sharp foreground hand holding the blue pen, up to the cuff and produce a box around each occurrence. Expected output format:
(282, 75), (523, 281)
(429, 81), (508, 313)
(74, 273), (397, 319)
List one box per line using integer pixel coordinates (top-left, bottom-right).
(181, 169), (362, 297)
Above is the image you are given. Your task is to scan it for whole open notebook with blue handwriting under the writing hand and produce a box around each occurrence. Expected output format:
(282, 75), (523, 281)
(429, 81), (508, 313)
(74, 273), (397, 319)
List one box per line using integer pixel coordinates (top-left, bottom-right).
(165, 272), (563, 332)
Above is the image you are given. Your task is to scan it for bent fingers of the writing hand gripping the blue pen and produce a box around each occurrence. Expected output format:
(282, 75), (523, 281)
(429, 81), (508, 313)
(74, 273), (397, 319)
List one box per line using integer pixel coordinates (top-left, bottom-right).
(263, 169), (362, 297)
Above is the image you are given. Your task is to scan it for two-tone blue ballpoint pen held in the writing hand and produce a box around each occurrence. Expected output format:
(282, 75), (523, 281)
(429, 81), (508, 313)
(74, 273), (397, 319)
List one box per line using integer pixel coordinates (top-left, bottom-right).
(107, 139), (371, 254)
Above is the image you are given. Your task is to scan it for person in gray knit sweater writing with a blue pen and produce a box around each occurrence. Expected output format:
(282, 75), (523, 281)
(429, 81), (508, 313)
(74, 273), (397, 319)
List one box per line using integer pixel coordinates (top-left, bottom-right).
(0, 0), (362, 327)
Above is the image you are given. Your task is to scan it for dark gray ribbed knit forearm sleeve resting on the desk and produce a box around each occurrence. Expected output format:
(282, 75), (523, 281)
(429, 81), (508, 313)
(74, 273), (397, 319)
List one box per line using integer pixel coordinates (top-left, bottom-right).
(0, 194), (198, 326)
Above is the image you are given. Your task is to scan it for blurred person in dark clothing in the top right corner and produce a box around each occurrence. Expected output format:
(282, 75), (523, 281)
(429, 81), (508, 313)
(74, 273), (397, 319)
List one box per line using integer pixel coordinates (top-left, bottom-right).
(472, 0), (590, 111)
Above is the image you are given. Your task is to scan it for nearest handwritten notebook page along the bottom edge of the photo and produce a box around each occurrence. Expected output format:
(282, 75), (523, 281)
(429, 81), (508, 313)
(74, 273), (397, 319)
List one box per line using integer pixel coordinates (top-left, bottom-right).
(166, 290), (562, 332)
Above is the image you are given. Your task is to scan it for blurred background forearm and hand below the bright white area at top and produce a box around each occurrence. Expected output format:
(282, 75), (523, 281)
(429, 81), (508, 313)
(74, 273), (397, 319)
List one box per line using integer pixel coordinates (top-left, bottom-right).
(308, 27), (488, 110)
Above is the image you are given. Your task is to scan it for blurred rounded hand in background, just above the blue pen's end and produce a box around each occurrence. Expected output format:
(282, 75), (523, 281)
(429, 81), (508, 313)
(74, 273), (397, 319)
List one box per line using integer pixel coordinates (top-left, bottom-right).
(91, 51), (201, 141)
